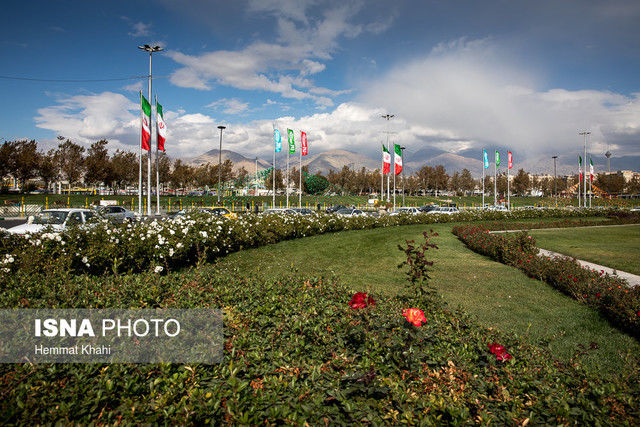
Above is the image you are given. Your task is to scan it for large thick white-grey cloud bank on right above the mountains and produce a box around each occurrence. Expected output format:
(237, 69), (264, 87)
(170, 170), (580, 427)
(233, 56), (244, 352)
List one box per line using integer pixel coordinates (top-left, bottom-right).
(359, 39), (640, 164)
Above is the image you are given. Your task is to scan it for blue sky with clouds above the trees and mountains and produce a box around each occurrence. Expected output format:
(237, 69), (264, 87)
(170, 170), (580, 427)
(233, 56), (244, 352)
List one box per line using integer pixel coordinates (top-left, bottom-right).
(0, 0), (640, 173)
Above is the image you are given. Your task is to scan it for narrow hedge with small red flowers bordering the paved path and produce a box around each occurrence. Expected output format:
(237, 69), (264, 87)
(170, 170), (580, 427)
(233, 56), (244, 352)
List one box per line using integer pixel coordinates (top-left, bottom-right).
(452, 225), (640, 338)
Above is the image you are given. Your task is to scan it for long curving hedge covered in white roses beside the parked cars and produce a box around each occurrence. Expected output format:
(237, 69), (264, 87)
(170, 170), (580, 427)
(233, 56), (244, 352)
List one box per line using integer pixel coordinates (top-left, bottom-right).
(0, 209), (640, 275)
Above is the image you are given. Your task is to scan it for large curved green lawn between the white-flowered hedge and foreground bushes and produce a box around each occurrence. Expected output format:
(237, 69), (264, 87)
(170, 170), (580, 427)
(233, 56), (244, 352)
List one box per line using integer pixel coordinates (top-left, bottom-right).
(218, 224), (640, 372)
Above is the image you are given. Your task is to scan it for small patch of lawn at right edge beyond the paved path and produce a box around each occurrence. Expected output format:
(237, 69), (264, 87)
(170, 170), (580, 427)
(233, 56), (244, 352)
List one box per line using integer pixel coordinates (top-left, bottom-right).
(531, 225), (640, 274)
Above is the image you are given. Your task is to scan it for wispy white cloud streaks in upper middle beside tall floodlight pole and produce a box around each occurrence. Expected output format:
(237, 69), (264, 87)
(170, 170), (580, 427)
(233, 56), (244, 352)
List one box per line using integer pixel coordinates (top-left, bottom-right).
(168, 0), (392, 108)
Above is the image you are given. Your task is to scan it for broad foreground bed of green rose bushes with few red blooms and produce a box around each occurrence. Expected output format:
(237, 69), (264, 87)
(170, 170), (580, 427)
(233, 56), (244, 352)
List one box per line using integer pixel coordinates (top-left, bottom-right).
(0, 266), (640, 425)
